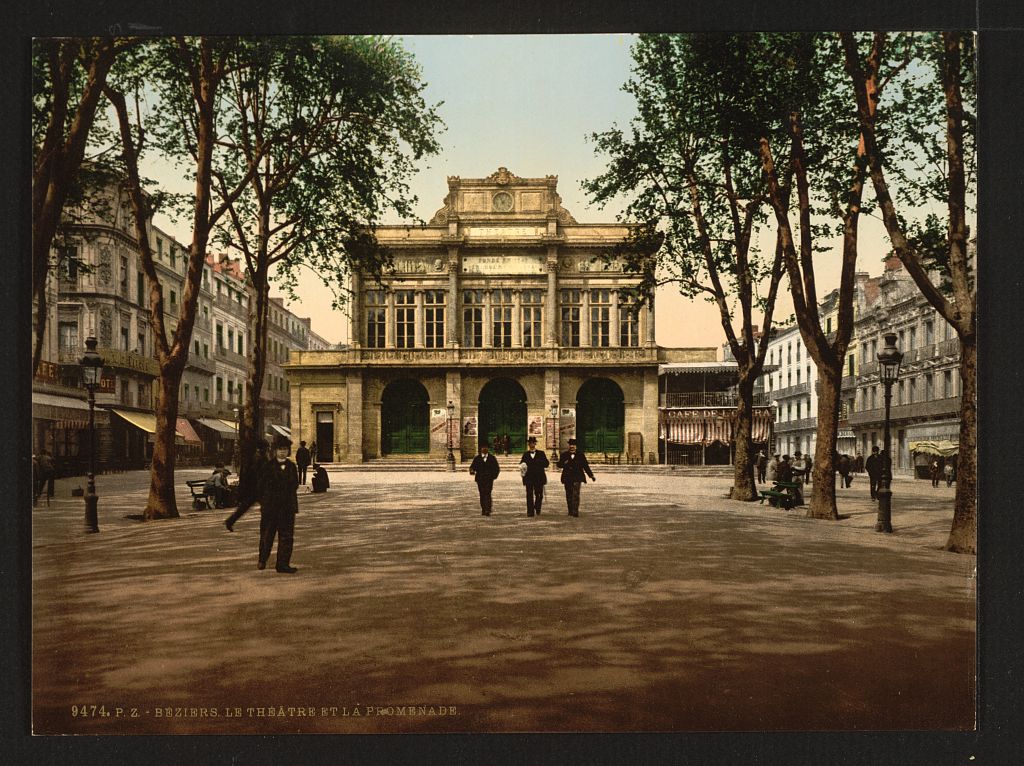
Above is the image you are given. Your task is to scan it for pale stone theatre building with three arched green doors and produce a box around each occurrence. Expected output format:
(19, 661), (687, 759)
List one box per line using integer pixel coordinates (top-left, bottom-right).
(282, 168), (716, 463)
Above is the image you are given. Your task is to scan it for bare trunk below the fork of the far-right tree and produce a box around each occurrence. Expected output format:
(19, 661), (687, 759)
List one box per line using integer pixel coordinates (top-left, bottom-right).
(945, 336), (978, 553)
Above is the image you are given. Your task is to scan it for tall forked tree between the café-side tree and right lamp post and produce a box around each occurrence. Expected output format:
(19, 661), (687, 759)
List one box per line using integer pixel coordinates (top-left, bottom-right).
(759, 35), (882, 519)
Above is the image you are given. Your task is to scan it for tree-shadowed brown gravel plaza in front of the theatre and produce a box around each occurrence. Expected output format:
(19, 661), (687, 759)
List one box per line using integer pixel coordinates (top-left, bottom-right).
(32, 465), (976, 734)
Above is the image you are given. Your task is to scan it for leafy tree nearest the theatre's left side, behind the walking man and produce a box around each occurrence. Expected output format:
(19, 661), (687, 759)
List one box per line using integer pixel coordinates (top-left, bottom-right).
(212, 37), (439, 479)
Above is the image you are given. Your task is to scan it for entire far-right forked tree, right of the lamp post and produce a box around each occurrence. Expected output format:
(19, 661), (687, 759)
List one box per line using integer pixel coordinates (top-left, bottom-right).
(841, 32), (978, 553)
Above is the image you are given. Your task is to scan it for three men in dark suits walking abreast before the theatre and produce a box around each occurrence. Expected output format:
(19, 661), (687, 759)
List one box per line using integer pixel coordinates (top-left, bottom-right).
(469, 436), (597, 517)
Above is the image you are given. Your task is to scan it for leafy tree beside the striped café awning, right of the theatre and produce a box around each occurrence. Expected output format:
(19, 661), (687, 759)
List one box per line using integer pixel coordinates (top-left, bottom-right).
(584, 34), (796, 500)
